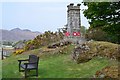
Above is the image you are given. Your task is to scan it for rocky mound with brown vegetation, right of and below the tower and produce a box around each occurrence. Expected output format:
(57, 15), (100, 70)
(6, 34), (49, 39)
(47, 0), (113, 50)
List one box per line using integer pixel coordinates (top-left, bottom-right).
(72, 41), (120, 63)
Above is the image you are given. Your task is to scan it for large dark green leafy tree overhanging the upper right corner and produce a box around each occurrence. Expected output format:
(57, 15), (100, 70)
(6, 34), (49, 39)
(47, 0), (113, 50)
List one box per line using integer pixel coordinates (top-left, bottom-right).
(84, 2), (120, 43)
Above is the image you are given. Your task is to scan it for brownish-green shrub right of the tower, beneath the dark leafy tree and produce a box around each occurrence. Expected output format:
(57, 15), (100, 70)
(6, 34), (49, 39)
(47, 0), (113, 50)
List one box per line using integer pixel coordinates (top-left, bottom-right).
(85, 27), (119, 43)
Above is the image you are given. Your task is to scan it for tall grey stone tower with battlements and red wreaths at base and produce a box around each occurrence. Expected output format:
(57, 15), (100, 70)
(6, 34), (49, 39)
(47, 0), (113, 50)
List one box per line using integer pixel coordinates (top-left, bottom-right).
(66, 3), (81, 42)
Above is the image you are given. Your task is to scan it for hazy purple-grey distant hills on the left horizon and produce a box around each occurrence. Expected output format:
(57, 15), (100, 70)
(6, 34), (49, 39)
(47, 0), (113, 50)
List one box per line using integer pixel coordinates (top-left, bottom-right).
(0, 28), (41, 41)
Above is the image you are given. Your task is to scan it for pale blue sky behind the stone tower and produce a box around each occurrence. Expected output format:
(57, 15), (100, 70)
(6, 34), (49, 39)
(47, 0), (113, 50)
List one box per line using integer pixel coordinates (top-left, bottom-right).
(0, 0), (89, 33)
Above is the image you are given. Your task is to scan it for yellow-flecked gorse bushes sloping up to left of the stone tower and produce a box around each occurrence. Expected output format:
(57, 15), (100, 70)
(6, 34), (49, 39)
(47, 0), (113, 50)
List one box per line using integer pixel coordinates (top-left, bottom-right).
(24, 31), (63, 50)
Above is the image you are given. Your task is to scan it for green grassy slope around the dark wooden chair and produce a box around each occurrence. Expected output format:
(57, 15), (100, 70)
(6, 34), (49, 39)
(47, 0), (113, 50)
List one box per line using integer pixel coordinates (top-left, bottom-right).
(2, 45), (113, 78)
